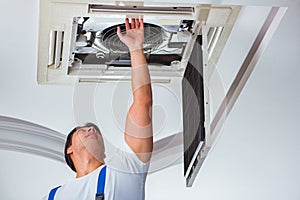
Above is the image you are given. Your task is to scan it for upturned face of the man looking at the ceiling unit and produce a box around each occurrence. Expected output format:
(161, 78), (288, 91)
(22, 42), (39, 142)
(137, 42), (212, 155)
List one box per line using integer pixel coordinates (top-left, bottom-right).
(68, 126), (105, 163)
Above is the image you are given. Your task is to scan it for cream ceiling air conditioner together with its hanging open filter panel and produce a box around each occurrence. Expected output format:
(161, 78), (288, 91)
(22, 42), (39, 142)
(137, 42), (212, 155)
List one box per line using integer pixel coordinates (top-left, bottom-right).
(38, 0), (241, 186)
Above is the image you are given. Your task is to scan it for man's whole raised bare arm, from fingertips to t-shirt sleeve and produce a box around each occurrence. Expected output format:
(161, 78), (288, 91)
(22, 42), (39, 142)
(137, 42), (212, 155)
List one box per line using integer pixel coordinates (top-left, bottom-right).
(117, 18), (153, 162)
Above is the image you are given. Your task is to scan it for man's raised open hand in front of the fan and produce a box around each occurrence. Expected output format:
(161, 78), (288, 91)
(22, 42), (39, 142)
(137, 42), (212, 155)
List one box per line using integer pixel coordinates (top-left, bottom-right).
(117, 18), (144, 51)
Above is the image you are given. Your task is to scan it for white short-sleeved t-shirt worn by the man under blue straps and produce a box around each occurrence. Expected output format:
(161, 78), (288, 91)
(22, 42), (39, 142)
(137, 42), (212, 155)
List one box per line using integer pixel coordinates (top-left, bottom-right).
(43, 142), (149, 200)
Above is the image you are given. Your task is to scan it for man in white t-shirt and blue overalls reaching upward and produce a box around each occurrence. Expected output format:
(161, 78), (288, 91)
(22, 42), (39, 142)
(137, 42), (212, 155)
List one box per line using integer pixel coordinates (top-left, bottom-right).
(45, 19), (153, 200)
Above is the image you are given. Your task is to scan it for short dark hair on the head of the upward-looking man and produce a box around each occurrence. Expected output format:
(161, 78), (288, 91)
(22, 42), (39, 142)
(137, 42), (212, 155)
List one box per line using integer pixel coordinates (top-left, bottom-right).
(64, 123), (101, 172)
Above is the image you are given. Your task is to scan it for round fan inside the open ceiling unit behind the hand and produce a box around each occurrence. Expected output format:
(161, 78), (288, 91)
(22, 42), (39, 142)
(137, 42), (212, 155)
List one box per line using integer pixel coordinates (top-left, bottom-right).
(95, 23), (165, 53)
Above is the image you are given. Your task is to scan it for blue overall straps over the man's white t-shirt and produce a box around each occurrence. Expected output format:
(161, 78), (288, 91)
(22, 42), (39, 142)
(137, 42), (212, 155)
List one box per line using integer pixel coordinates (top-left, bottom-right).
(48, 166), (106, 200)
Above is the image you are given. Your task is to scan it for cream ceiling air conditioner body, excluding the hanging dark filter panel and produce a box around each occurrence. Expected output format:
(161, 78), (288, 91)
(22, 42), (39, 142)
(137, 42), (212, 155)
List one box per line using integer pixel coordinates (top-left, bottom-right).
(38, 0), (240, 84)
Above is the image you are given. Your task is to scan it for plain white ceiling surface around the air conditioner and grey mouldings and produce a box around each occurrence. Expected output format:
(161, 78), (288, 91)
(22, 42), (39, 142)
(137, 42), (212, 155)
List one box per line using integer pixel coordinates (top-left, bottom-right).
(0, 0), (300, 200)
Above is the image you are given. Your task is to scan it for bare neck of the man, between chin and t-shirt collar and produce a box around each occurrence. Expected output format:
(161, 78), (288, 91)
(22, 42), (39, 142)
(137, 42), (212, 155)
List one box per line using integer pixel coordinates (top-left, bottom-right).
(76, 155), (103, 178)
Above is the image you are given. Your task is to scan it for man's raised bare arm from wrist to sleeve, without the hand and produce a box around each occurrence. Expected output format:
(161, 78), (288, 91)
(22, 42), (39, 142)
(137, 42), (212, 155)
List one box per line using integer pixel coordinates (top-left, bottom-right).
(125, 50), (153, 159)
